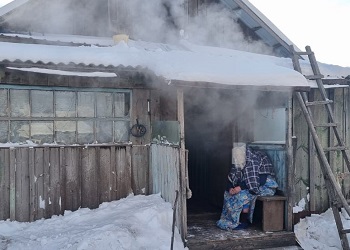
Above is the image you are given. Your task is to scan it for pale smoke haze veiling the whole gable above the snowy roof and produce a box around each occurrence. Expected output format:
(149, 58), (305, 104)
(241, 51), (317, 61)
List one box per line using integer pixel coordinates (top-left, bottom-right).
(4, 0), (272, 54)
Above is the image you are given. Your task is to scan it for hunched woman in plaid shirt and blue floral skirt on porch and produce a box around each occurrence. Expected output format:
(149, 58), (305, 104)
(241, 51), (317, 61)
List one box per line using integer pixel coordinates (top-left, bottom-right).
(216, 144), (278, 230)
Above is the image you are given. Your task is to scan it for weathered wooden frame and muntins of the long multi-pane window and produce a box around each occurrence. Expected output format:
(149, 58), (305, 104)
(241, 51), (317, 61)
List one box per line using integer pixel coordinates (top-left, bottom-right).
(0, 84), (132, 145)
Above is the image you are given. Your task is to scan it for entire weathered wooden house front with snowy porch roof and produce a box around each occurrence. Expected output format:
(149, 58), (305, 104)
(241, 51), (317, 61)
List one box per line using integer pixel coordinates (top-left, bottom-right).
(0, 0), (348, 247)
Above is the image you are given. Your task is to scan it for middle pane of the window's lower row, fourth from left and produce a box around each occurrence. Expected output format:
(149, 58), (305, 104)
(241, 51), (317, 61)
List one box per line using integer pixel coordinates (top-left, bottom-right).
(55, 121), (76, 144)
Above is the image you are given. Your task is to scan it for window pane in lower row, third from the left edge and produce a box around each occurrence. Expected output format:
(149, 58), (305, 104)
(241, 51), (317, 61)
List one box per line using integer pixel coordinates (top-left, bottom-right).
(31, 122), (53, 144)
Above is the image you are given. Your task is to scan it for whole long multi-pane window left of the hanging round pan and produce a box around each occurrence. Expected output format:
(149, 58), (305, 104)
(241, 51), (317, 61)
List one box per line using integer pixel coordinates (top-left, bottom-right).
(0, 85), (131, 145)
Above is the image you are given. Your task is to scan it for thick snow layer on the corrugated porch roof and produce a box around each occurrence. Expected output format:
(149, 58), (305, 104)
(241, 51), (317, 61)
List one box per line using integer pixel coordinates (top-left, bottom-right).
(0, 38), (309, 87)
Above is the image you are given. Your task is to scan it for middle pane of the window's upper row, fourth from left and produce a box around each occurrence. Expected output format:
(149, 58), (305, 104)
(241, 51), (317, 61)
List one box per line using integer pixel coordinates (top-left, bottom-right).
(55, 91), (75, 117)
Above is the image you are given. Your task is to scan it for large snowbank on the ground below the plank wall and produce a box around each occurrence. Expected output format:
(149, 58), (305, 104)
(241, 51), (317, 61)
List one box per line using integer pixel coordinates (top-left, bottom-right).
(0, 194), (187, 250)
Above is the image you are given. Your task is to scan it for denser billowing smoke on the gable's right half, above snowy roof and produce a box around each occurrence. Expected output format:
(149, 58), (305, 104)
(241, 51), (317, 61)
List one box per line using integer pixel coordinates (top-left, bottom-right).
(111, 0), (272, 54)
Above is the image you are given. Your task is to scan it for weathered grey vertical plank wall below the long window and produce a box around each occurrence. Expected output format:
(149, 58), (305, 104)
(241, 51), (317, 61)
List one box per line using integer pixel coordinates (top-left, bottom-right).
(0, 146), (141, 222)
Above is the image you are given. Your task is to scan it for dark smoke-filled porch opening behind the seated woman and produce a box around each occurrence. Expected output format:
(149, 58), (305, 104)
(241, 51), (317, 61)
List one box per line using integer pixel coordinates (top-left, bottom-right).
(184, 88), (288, 214)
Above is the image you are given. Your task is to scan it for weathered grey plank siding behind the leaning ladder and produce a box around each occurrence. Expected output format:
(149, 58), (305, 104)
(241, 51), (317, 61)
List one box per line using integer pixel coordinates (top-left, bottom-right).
(293, 88), (350, 212)
